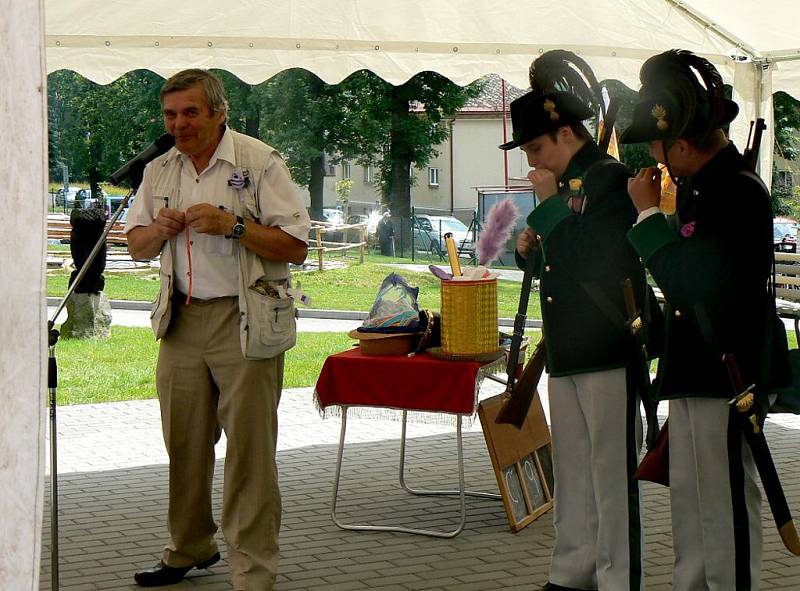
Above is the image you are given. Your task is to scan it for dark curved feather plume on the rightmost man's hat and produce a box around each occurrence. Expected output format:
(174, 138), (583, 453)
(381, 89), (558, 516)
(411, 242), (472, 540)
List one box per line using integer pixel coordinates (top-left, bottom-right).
(639, 49), (726, 140)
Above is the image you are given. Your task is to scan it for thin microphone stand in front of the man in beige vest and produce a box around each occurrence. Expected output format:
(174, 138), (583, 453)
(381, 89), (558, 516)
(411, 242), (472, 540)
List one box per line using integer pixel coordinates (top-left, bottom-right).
(47, 191), (138, 591)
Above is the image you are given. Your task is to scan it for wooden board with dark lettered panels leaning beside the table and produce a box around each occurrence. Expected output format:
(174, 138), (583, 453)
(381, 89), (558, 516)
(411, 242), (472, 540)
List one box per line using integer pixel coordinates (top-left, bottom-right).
(478, 393), (553, 533)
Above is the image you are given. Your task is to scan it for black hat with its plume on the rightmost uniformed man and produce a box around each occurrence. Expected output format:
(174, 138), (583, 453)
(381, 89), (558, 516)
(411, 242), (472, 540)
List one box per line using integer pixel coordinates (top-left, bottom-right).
(619, 49), (739, 144)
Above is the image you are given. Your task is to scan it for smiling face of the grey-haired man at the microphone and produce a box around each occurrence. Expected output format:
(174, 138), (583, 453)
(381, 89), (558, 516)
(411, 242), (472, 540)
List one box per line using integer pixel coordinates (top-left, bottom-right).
(161, 85), (224, 156)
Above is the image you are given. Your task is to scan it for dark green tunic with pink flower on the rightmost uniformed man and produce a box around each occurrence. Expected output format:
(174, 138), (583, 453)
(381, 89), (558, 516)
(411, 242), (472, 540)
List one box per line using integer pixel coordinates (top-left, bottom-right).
(629, 144), (788, 405)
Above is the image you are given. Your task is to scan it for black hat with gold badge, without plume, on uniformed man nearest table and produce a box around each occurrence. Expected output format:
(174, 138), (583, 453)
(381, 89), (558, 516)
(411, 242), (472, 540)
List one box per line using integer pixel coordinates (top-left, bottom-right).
(499, 91), (594, 150)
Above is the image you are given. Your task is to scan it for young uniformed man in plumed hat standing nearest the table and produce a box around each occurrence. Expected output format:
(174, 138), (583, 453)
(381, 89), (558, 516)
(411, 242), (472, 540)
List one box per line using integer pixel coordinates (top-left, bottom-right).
(500, 52), (645, 591)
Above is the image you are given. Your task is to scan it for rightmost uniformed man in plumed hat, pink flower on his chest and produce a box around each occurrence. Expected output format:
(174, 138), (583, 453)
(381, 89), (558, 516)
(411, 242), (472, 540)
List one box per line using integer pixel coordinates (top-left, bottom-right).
(620, 51), (787, 591)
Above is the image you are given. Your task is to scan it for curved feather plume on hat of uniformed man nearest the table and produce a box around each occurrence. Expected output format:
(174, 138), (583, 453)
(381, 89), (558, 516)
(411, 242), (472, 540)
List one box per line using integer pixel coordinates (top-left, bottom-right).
(528, 49), (605, 115)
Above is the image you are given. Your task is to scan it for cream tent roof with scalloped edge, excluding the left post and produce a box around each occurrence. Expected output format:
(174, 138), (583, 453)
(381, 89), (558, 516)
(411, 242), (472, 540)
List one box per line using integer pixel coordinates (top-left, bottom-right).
(45, 0), (800, 182)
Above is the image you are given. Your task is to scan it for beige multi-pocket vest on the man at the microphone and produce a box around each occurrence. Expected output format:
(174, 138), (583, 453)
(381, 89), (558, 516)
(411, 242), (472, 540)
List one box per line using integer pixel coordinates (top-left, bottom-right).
(150, 130), (297, 359)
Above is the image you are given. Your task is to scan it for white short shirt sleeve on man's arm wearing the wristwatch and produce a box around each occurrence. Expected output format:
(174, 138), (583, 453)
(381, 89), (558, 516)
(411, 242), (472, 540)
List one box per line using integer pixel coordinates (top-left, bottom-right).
(258, 152), (311, 244)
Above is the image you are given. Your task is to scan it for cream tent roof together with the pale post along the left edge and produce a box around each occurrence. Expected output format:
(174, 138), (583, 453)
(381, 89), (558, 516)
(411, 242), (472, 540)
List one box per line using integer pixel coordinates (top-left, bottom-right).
(0, 0), (800, 591)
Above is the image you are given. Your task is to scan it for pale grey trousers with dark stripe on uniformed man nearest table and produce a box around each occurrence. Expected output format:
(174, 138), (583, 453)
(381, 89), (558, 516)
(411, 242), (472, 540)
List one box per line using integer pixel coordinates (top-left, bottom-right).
(547, 369), (644, 591)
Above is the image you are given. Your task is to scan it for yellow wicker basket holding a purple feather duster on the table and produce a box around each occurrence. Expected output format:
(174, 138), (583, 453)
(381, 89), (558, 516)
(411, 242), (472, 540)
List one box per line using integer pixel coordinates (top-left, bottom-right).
(442, 279), (498, 356)
